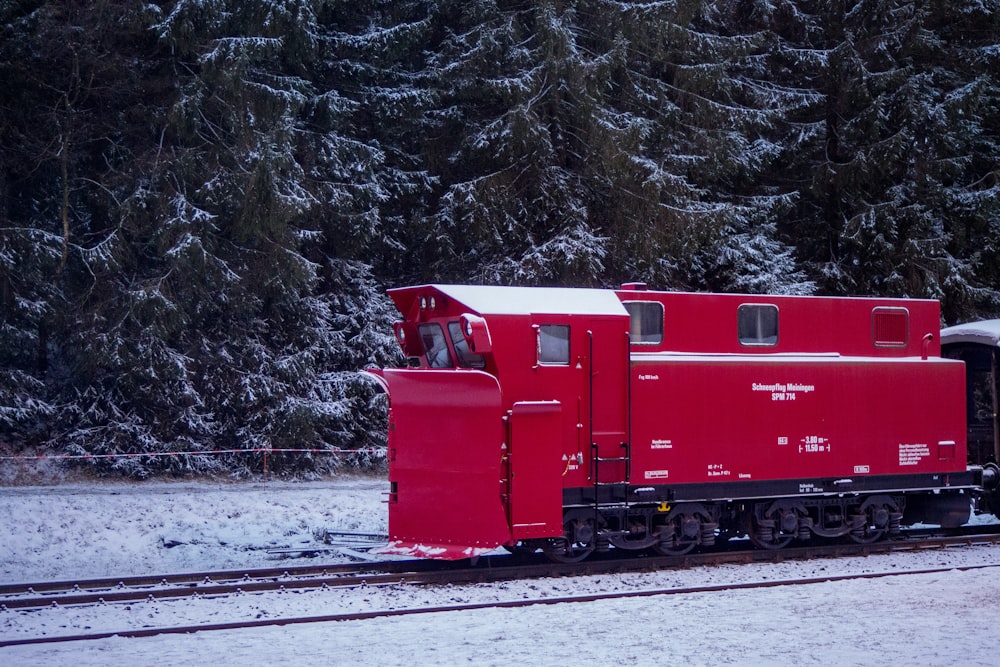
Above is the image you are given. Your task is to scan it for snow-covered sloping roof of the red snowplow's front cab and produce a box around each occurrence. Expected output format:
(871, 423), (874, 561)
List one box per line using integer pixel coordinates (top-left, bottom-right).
(389, 285), (628, 316)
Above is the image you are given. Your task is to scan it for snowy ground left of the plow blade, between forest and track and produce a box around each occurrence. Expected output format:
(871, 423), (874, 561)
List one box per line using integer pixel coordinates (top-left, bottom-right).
(0, 477), (389, 582)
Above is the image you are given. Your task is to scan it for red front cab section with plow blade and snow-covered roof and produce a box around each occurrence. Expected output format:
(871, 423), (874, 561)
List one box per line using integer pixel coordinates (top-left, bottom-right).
(370, 285), (629, 558)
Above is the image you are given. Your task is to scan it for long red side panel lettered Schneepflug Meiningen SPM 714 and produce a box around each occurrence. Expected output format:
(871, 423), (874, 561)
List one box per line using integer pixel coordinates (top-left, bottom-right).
(632, 355), (966, 484)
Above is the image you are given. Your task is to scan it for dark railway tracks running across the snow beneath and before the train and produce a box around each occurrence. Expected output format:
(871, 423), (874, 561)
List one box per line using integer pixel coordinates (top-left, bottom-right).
(0, 526), (1000, 647)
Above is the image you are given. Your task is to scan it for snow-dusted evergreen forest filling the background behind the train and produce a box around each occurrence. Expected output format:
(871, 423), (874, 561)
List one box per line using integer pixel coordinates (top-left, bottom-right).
(0, 0), (1000, 478)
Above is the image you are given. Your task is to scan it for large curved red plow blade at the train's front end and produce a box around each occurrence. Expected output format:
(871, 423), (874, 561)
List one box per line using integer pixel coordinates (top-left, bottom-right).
(366, 369), (510, 559)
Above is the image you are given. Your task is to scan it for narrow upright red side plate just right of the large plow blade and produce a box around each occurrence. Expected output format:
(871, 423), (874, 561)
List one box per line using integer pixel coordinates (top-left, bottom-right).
(510, 401), (569, 540)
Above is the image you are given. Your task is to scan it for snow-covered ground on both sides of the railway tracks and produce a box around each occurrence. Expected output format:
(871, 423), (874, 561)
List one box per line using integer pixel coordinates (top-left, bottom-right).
(0, 476), (1000, 666)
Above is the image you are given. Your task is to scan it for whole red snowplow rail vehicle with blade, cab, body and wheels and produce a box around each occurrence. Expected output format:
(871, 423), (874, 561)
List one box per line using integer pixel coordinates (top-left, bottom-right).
(372, 284), (1000, 562)
